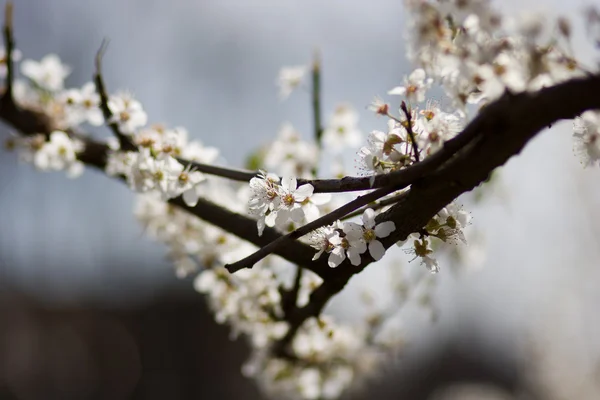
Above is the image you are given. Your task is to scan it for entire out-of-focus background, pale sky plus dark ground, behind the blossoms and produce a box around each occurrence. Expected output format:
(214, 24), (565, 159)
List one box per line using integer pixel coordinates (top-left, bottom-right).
(0, 0), (600, 400)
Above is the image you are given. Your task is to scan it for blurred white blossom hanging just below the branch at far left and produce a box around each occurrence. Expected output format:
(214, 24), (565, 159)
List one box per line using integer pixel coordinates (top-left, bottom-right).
(33, 131), (83, 178)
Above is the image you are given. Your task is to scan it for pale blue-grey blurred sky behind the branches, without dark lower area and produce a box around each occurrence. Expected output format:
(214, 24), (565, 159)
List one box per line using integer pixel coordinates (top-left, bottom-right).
(0, 0), (600, 378)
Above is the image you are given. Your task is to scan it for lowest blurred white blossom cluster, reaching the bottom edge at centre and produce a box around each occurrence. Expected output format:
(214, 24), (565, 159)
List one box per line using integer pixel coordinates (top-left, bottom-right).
(243, 317), (386, 400)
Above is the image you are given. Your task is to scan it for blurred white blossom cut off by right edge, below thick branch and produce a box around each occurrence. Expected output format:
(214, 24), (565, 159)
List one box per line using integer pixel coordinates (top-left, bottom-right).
(573, 111), (600, 167)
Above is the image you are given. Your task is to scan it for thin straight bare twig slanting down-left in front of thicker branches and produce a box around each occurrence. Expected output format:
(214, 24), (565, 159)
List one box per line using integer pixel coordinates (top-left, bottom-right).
(225, 187), (399, 273)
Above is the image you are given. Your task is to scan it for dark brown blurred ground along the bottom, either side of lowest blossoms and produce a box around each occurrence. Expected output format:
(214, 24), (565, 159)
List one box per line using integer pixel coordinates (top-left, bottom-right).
(0, 286), (533, 400)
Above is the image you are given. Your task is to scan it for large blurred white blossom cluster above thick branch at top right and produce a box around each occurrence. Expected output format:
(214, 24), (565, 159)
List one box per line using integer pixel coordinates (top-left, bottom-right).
(406, 0), (583, 110)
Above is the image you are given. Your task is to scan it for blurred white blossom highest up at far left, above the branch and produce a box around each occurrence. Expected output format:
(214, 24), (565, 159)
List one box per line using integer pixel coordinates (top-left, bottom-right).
(21, 54), (71, 92)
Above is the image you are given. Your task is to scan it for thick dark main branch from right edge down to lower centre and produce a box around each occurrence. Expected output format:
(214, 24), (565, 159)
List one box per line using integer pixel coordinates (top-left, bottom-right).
(273, 75), (600, 357)
